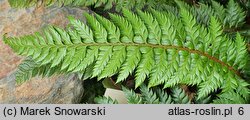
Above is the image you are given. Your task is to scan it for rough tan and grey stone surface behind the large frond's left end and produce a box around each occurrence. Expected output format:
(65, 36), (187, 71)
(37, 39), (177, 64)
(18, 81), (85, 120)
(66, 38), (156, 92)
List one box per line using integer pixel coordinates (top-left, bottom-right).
(0, 0), (86, 103)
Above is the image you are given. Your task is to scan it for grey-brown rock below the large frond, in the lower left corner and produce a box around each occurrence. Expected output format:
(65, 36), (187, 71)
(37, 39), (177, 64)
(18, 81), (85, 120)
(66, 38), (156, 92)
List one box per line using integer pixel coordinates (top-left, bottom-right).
(0, 73), (84, 104)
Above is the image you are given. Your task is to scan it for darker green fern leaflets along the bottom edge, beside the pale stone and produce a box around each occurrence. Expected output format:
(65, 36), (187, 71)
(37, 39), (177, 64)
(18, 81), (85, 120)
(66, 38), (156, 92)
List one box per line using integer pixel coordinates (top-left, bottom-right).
(95, 85), (191, 104)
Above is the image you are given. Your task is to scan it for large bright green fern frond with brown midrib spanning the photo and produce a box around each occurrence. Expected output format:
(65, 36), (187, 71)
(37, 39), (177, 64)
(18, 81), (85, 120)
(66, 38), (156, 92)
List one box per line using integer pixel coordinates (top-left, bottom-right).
(4, 9), (250, 103)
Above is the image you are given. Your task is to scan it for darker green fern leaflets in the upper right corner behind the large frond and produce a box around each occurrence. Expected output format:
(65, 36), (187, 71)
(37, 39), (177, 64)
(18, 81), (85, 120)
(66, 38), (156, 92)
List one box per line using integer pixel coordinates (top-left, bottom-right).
(176, 0), (246, 29)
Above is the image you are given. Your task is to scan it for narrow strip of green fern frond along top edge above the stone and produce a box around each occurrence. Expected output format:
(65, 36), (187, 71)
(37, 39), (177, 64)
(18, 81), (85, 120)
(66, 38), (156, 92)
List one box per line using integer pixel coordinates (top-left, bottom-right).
(9, 0), (173, 11)
